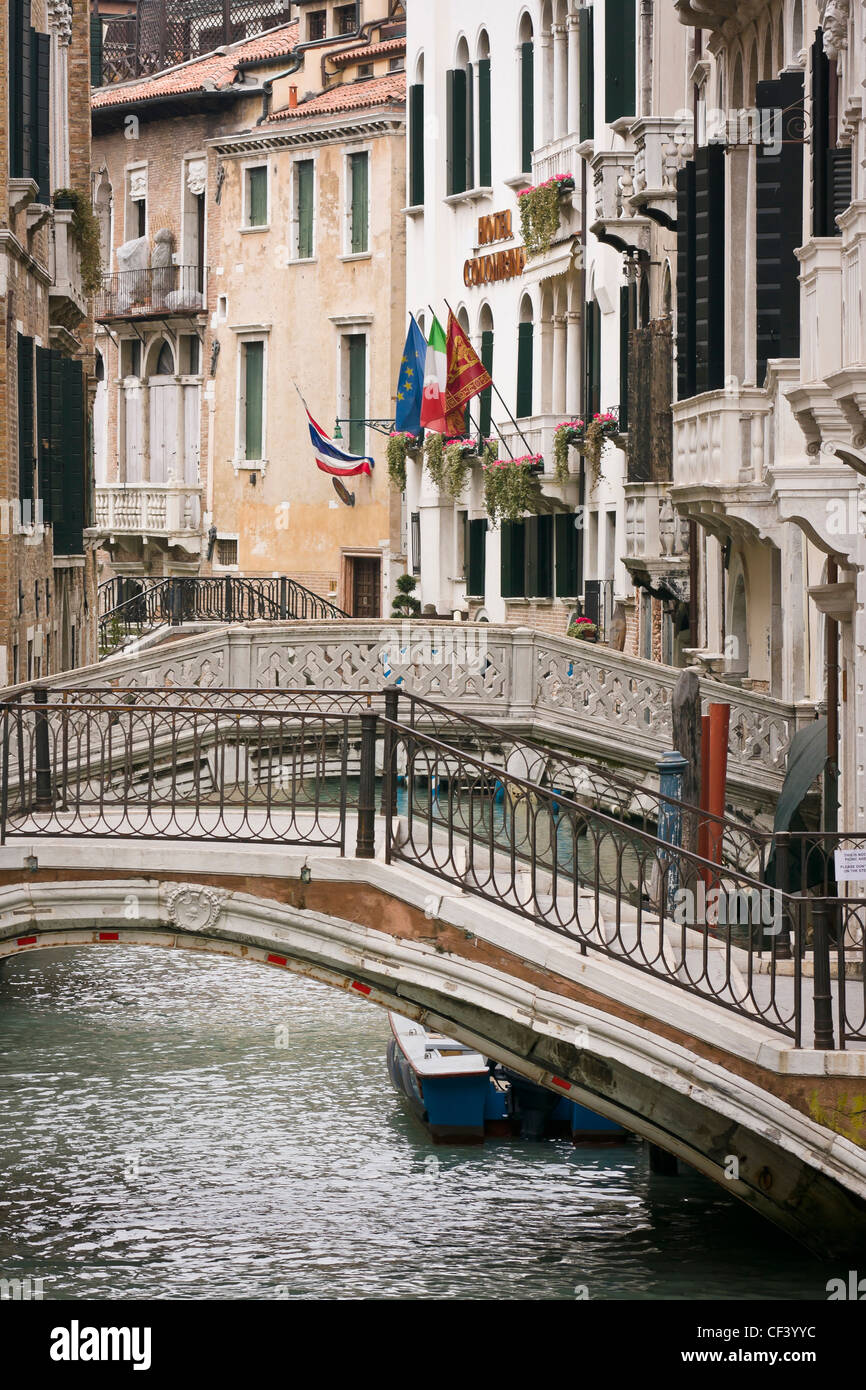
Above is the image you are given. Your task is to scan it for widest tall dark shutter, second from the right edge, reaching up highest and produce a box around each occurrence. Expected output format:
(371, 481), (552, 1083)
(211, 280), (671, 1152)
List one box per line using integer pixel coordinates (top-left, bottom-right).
(755, 72), (803, 385)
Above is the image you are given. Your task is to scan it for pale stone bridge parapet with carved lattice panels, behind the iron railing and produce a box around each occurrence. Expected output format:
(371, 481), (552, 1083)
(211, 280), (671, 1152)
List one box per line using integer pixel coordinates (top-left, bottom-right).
(20, 619), (815, 803)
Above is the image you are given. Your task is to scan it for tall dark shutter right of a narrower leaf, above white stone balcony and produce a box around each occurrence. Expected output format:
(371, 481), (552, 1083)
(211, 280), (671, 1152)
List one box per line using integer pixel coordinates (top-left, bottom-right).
(695, 145), (726, 395)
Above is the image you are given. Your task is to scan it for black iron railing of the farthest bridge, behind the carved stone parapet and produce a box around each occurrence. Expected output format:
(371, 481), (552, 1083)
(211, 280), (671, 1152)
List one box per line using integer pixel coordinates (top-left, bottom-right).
(99, 574), (348, 656)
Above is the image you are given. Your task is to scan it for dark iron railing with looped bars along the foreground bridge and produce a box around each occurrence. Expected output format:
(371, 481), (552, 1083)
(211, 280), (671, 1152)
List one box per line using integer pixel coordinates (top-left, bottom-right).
(0, 687), (866, 1048)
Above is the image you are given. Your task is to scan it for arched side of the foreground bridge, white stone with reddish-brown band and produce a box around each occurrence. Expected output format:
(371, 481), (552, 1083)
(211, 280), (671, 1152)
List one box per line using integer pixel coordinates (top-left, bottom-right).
(0, 838), (866, 1257)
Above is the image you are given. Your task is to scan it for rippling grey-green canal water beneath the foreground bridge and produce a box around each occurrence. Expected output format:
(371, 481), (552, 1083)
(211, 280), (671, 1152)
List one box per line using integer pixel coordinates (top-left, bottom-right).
(0, 947), (840, 1301)
